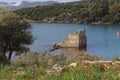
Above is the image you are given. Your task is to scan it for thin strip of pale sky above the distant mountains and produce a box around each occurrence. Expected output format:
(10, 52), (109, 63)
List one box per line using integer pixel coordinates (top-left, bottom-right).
(0, 0), (79, 3)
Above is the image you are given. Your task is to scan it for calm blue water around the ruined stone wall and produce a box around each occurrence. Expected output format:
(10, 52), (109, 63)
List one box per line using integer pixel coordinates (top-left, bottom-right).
(30, 23), (120, 59)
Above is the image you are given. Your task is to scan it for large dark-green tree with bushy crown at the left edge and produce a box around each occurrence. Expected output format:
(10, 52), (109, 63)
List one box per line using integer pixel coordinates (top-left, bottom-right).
(0, 8), (33, 60)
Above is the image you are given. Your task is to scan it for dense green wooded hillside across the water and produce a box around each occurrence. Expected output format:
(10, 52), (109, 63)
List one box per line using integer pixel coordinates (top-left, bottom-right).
(15, 0), (120, 24)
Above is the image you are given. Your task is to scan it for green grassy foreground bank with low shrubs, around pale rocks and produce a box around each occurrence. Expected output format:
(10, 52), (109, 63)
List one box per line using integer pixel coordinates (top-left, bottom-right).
(0, 53), (120, 80)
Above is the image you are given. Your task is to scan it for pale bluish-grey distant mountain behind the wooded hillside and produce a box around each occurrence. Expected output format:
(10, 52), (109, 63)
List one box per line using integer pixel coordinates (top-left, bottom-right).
(0, 1), (59, 10)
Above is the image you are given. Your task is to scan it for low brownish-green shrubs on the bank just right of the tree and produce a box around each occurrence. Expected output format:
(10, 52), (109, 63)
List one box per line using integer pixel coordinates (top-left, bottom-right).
(13, 52), (66, 65)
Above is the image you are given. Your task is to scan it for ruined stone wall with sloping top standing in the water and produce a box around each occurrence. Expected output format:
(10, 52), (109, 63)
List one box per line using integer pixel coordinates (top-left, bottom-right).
(54, 30), (87, 48)
